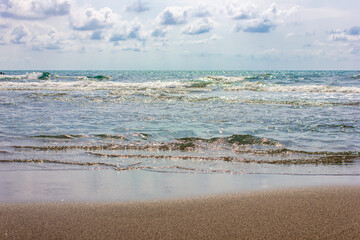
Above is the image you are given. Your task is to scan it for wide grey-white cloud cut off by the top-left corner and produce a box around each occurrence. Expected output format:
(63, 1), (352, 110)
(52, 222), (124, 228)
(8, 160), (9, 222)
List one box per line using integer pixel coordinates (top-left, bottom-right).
(0, 0), (71, 20)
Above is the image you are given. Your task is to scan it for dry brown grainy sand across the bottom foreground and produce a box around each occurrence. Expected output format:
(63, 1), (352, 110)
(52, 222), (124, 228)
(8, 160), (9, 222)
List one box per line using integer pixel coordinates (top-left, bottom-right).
(0, 187), (360, 239)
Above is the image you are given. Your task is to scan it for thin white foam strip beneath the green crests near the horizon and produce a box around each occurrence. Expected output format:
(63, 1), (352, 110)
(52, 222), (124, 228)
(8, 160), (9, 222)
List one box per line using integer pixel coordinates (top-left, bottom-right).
(0, 81), (360, 93)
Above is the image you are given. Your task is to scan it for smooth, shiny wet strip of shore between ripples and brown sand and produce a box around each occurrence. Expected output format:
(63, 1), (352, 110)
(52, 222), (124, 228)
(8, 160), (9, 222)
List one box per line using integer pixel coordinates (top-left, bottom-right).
(0, 170), (360, 204)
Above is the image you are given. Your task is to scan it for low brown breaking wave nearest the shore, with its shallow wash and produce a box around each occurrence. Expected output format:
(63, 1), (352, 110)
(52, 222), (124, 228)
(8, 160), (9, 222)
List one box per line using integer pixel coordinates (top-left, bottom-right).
(0, 129), (360, 176)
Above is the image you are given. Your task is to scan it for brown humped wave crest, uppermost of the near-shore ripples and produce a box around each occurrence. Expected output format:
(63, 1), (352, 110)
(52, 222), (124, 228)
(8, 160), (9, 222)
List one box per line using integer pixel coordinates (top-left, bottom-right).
(17, 133), (360, 154)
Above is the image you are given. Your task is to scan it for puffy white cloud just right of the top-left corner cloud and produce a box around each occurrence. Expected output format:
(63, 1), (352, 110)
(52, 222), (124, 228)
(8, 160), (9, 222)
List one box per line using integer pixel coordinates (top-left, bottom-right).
(70, 7), (117, 31)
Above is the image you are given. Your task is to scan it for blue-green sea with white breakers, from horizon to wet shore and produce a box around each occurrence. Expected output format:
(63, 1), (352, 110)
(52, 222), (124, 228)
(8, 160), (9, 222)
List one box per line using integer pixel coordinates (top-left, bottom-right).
(0, 70), (360, 201)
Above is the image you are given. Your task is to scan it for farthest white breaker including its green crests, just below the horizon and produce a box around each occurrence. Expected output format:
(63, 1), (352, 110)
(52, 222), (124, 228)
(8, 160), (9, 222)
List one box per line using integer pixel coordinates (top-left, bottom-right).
(0, 72), (360, 94)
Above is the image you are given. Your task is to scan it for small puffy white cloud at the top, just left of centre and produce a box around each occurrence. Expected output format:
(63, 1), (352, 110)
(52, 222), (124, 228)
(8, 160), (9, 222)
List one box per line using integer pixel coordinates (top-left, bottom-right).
(157, 6), (189, 25)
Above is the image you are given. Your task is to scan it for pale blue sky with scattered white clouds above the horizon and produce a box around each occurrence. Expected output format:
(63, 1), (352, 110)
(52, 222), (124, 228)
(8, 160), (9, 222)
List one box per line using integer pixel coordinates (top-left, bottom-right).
(0, 0), (360, 70)
